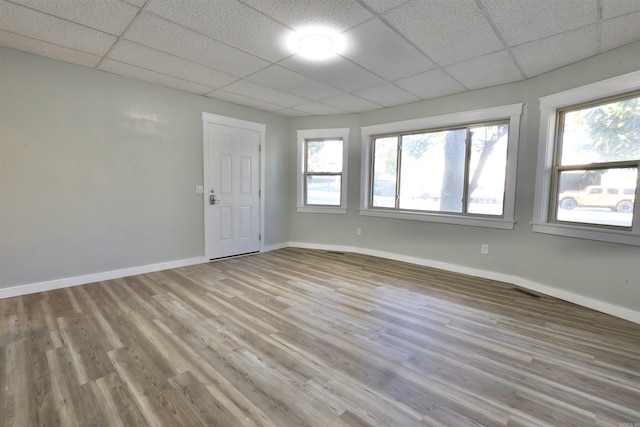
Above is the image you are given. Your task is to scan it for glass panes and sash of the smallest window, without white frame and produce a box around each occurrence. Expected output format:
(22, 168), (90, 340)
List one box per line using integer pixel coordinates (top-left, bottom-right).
(304, 139), (343, 206)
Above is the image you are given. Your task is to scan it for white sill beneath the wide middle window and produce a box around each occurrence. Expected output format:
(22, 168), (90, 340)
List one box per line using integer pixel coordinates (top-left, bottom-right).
(360, 209), (515, 230)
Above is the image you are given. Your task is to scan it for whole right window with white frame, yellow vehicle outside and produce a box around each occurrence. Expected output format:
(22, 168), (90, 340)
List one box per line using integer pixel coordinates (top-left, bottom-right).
(533, 73), (640, 245)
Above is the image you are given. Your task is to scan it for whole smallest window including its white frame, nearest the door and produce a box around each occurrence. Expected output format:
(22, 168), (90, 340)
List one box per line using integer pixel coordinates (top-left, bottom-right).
(298, 129), (349, 213)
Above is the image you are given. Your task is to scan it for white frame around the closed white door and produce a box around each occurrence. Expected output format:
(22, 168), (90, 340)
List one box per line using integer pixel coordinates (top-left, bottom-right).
(202, 112), (267, 260)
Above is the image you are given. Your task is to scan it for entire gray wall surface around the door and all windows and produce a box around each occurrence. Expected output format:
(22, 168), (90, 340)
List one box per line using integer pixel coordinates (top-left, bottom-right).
(0, 43), (640, 318)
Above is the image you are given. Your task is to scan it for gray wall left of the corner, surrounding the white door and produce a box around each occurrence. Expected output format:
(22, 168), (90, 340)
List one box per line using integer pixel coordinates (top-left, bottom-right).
(0, 48), (289, 288)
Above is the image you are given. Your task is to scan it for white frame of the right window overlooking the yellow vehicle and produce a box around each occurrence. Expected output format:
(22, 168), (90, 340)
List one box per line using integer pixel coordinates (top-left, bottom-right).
(531, 71), (640, 246)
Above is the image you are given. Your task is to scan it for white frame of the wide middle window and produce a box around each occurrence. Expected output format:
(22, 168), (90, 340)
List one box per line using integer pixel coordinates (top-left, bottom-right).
(360, 103), (524, 230)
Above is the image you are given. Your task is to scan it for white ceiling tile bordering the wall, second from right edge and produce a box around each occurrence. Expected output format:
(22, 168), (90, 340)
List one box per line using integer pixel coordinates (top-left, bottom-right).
(511, 25), (598, 77)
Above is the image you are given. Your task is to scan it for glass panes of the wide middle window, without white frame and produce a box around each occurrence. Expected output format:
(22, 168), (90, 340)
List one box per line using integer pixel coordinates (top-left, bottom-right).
(370, 121), (509, 217)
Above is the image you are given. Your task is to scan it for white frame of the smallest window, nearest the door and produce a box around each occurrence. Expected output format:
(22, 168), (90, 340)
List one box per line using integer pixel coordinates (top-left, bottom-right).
(296, 128), (349, 214)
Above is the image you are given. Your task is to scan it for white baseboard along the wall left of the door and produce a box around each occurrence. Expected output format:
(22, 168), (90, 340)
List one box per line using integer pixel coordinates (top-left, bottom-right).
(0, 257), (209, 299)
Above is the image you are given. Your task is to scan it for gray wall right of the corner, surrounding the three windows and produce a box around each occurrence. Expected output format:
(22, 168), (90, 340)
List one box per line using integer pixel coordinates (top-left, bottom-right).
(289, 43), (640, 318)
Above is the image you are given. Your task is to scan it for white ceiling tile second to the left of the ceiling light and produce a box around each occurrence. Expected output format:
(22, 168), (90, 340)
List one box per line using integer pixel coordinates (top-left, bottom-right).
(126, 13), (271, 77)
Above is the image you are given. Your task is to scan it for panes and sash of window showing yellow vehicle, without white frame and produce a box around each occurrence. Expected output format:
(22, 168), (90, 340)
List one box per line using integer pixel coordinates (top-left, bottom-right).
(549, 93), (640, 230)
